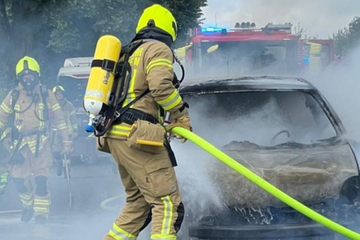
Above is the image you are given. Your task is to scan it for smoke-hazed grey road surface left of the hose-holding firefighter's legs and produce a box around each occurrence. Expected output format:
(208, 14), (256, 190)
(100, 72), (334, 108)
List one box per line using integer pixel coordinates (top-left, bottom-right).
(0, 163), (139, 240)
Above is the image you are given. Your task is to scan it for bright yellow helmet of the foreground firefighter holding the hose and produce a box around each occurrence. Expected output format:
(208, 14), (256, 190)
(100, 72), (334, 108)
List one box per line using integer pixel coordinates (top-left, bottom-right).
(136, 4), (177, 42)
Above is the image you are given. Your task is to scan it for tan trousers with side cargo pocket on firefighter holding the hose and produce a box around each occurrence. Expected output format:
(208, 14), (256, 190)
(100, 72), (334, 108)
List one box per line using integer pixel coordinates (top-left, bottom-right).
(104, 139), (184, 240)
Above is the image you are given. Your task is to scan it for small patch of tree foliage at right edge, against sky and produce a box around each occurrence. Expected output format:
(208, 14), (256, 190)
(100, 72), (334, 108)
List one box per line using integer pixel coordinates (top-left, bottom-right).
(333, 17), (360, 56)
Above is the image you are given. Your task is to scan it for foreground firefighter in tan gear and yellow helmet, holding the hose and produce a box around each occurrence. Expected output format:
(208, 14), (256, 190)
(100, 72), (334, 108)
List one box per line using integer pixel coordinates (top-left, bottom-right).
(104, 4), (190, 240)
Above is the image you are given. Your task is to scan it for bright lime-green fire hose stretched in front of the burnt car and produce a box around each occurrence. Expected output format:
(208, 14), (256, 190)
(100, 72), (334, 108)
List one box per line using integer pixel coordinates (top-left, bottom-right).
(171, 127), (360, 240)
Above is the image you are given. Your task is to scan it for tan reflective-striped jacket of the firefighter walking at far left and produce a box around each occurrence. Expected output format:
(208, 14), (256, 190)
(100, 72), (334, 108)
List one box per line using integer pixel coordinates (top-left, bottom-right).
(0, 84), (68, 154)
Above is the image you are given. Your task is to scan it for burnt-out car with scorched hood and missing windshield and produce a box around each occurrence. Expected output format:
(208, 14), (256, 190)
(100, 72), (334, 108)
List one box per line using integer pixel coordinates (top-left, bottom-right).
(180, 76), (360, 239)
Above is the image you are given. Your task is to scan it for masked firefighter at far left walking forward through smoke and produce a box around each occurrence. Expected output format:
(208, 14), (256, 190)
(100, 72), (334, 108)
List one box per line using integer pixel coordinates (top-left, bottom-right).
(0, 56), (72, 224)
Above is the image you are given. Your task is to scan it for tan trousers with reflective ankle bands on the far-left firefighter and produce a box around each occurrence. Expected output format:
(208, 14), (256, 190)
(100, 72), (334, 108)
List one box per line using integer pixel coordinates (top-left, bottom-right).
(10, 142), (53, 218)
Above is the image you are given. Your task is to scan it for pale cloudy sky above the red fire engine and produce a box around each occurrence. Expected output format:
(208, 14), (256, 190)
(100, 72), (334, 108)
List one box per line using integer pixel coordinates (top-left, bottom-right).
(203, 0), (360, 38)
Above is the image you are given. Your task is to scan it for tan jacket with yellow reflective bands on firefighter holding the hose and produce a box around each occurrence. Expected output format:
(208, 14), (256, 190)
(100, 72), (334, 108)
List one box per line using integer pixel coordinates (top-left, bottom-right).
(106, 40), (187, 139)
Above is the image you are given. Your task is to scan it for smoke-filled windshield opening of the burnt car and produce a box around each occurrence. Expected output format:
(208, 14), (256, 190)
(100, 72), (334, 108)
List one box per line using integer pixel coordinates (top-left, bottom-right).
(186, 91), (337, 146)
